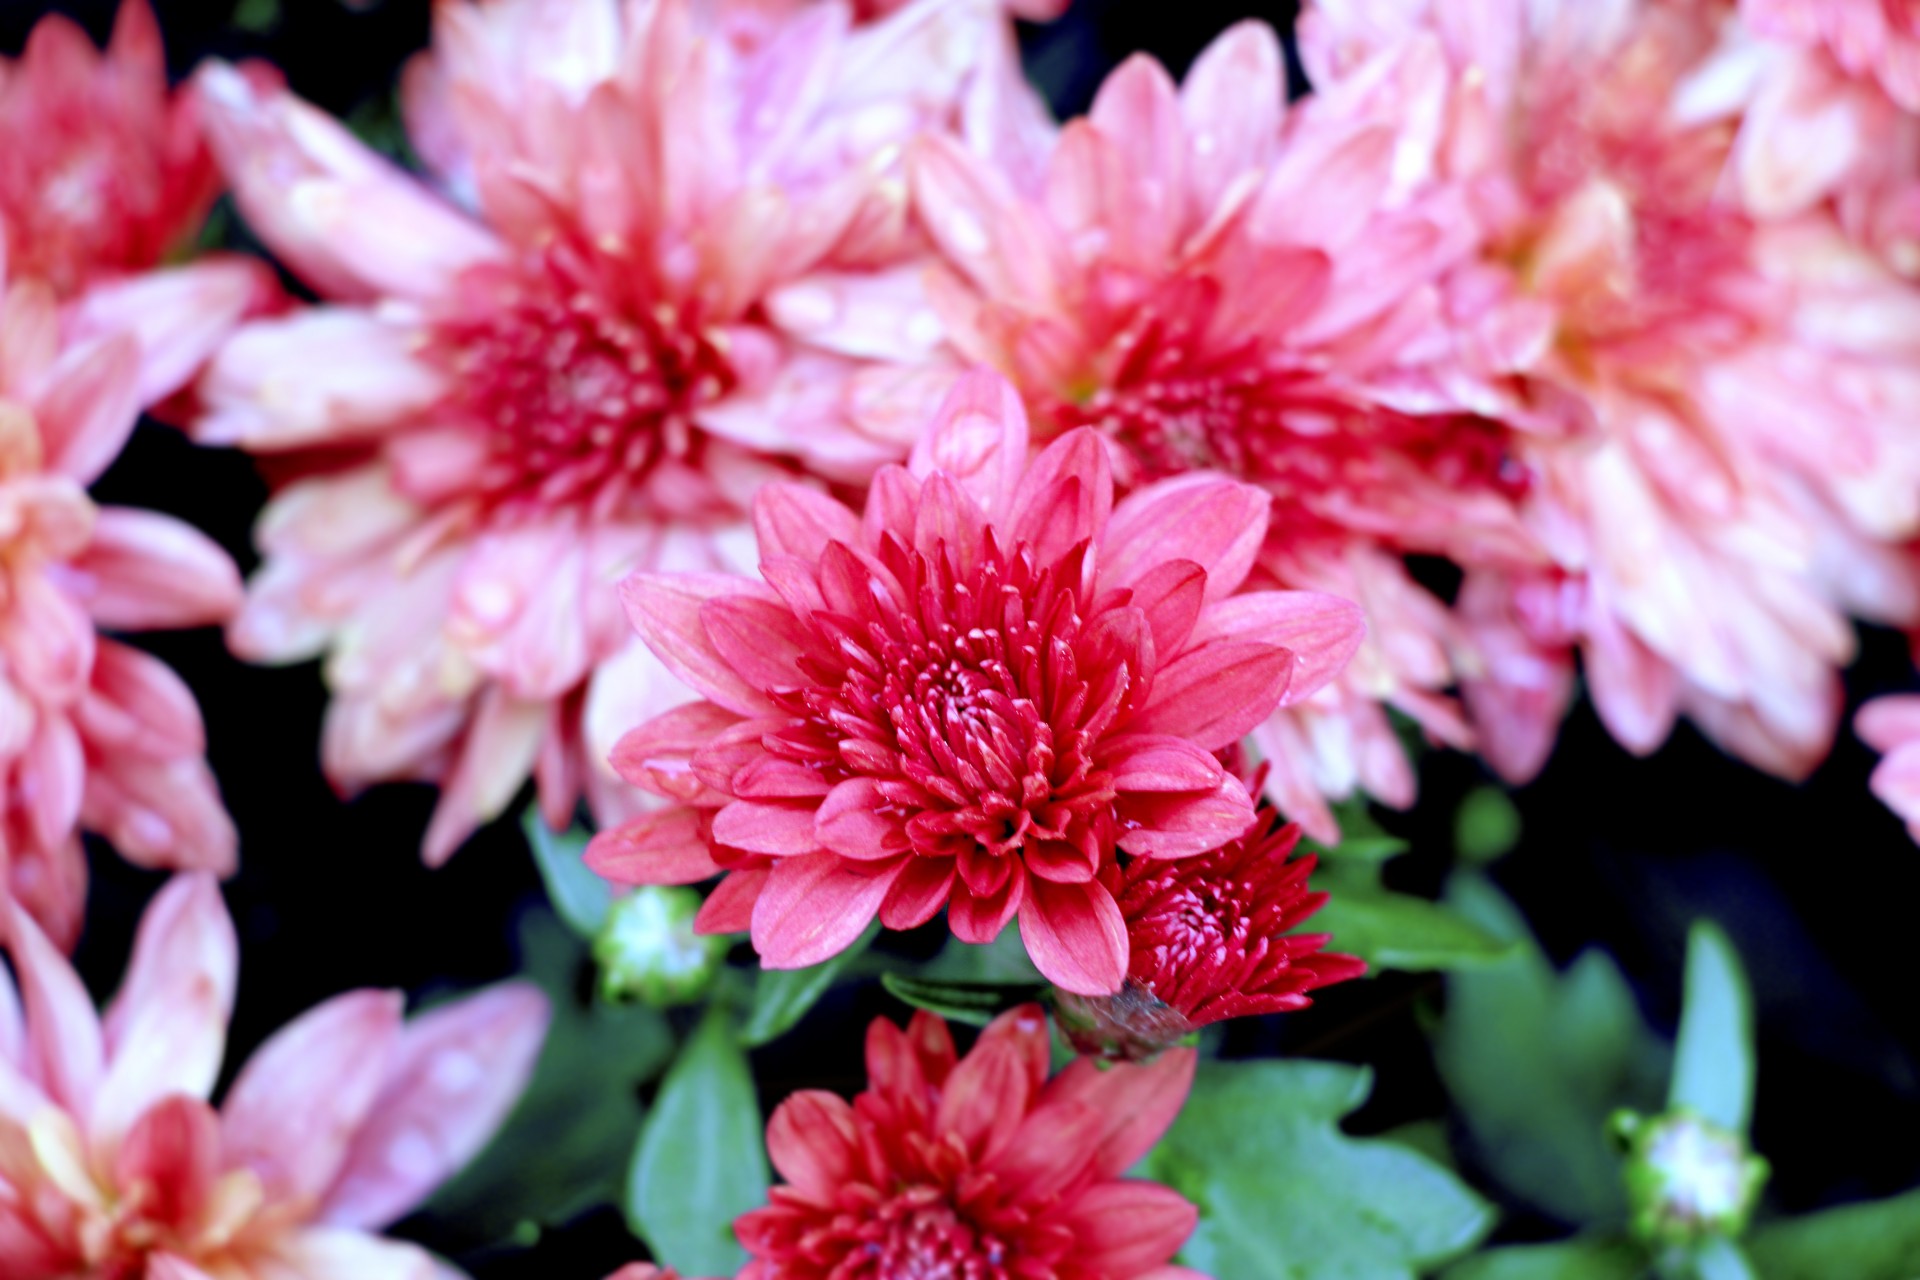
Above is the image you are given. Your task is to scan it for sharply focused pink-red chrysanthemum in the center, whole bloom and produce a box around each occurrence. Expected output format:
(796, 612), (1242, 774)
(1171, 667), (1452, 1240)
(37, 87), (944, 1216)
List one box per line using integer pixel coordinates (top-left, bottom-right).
(588, 372), (1361, 994)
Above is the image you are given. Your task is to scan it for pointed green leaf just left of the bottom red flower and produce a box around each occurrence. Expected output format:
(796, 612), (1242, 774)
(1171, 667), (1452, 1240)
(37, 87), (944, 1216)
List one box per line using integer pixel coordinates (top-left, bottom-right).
(626, 1009), (768, 1276)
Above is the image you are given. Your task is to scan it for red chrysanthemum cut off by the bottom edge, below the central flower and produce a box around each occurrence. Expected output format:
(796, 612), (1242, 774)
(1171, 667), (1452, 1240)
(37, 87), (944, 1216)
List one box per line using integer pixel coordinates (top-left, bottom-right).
(735, 1006), (1204, 1280)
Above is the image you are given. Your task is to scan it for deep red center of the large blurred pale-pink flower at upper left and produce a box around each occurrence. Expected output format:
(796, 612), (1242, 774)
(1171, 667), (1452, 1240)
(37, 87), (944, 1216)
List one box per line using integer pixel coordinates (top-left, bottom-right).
(428, 251), (733, 512)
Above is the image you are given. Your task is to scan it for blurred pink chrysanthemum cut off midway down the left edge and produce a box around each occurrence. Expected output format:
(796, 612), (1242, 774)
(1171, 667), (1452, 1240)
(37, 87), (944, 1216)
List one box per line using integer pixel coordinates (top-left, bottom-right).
(0, 245), (250, 946)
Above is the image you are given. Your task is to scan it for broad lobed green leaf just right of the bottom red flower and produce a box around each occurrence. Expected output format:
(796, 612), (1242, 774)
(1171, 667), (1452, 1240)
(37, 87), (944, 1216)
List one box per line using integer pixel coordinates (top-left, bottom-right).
(1146, 1061), (1494, 1280)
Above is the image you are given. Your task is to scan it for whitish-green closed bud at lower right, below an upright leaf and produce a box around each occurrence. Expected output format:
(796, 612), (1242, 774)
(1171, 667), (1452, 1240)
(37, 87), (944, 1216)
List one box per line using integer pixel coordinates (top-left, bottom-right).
(1609, 1109), (1768, 1245)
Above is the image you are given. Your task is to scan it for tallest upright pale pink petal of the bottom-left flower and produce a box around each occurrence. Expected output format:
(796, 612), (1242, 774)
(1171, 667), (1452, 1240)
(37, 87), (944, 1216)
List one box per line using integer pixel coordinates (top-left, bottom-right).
(92, 871), (240, 1159)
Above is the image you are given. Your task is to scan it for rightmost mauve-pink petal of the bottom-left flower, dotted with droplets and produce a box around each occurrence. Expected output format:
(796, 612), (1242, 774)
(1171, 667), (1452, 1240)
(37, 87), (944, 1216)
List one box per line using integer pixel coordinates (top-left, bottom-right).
(321, 983), (549, 1230)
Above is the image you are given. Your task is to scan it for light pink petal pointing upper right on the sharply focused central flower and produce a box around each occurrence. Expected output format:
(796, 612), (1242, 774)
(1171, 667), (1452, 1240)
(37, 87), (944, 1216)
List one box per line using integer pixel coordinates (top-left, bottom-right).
(1098, 472), (1271, 603)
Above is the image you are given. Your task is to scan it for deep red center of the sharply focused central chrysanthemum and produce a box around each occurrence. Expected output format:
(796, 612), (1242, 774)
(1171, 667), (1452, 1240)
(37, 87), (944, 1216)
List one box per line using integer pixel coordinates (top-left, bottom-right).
(768, 533), (1139, 871)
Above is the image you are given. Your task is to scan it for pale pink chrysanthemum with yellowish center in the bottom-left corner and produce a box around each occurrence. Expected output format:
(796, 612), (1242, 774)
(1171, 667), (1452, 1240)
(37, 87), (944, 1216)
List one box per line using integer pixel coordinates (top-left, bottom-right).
(0, 875), (547, 1280)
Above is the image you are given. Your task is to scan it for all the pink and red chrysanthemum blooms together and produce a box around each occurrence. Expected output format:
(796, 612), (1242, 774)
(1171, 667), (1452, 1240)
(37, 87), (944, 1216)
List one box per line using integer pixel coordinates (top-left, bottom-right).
(11, 0), (1920, 1280)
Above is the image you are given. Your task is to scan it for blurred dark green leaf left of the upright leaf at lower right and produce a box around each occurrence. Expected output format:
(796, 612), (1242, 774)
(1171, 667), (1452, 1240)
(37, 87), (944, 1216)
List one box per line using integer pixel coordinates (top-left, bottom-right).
(1434, 873), (1667, 1226)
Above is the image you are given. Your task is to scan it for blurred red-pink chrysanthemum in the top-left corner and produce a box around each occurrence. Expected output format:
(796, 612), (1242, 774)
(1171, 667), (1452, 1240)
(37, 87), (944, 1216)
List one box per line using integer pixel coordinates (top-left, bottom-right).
(0, 0), (219, 297)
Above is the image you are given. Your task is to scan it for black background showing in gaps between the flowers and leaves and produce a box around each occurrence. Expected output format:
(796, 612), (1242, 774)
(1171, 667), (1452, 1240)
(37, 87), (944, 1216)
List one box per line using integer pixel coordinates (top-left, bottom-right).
(15, 0), (1920, 1280)
